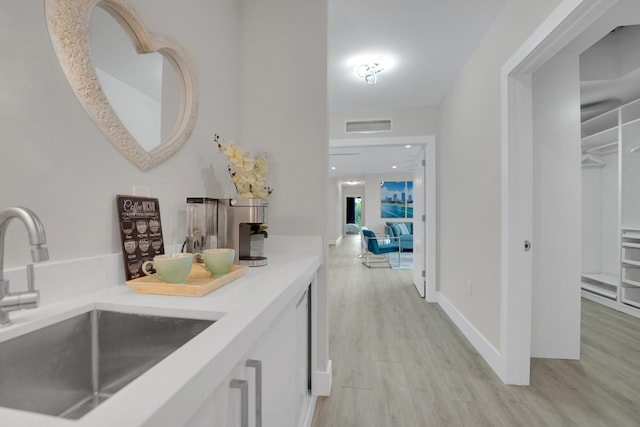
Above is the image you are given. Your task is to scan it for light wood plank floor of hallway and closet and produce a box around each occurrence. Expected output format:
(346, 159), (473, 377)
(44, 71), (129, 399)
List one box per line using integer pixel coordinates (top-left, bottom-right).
(312, 236), (640, 427)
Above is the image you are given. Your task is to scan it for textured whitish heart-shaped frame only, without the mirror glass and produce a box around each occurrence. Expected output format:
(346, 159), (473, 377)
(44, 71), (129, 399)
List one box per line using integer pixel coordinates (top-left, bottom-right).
(45, 0), (199, 171)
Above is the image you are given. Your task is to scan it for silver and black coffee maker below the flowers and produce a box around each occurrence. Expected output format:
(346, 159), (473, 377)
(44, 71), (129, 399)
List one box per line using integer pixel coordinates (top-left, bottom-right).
(218, 199), (267, 267)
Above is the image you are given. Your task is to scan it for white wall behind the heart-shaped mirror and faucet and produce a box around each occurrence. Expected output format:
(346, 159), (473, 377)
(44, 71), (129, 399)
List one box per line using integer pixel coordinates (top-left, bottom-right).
(0, 0), (241, 267)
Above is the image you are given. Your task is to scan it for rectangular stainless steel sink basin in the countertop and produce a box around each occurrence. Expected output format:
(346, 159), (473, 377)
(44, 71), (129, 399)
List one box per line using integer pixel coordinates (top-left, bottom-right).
(0, 310), (214, 419)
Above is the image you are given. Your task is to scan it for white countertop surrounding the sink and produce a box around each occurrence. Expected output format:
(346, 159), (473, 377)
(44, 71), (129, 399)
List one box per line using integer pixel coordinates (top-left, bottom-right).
(0, 242), (323, 427)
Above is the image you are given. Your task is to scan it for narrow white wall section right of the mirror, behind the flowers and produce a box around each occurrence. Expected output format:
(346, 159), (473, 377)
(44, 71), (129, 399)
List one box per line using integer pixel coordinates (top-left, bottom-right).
(242, 0), (329, 239)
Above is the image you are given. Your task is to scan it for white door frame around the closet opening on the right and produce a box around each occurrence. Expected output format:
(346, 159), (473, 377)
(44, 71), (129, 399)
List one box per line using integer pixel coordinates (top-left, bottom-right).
(498, 0), (617, 385)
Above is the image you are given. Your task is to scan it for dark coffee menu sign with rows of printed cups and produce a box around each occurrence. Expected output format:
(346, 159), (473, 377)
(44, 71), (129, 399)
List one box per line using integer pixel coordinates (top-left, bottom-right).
(116, 195), (164, 280)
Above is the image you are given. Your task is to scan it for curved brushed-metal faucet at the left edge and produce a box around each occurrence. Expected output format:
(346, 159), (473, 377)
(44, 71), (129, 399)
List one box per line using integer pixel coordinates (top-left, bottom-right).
(0, 206), (49, 327)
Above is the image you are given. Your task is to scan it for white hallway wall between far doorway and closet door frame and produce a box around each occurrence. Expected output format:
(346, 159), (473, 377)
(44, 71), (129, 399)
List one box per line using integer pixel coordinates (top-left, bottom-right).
(437, 0), (560, 348)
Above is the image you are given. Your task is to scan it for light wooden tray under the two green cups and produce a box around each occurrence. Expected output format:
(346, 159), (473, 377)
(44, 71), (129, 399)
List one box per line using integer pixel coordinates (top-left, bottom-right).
(127, 264), (248, 297)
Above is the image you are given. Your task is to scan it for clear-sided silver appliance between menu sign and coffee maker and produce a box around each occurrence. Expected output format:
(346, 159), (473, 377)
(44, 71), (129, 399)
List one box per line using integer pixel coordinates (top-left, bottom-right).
(183, 197), (218, 253)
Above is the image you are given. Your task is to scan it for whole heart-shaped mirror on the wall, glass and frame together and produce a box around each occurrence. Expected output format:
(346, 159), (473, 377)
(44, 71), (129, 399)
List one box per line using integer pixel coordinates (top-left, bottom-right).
(45, 0), (198, 170)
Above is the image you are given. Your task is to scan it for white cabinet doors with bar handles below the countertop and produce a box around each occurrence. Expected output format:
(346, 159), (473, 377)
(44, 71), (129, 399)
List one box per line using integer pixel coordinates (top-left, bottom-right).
(187, 291), (308, 427)
